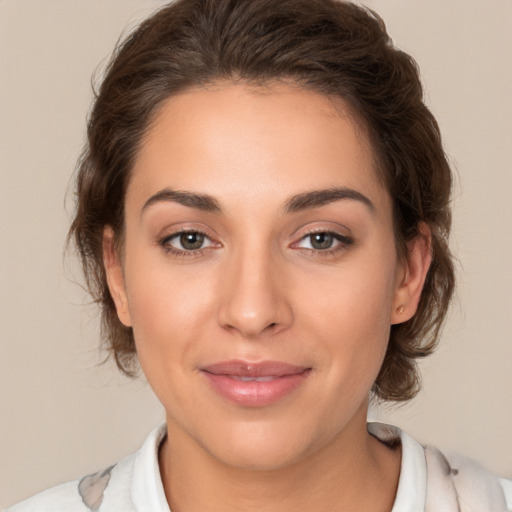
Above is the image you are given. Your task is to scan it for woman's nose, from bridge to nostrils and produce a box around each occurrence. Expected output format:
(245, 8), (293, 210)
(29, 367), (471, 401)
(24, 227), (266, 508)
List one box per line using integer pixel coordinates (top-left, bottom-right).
(218, 245), (293, 339)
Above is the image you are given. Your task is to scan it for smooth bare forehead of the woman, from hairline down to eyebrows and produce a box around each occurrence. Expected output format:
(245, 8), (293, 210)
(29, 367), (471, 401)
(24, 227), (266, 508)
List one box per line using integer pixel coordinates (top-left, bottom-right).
(127, 84), (387, 212)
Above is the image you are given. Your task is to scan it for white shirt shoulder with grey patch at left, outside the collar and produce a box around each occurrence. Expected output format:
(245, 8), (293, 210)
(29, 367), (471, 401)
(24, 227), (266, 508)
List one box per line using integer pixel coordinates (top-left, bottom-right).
(6, 455), (135, 512)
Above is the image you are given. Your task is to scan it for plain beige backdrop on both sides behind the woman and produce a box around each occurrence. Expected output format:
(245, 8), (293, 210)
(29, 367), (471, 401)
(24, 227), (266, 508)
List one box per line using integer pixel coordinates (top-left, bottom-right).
(0, 0), (512, 507)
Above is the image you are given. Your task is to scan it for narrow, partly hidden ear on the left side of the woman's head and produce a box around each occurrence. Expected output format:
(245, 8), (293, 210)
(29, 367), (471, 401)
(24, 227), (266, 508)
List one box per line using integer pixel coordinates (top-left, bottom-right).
(103, 226), (132, 327)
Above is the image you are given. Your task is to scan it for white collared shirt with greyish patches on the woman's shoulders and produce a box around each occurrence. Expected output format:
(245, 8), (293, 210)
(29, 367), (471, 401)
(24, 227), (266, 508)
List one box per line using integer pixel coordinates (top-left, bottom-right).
(6, 423), (512, 512)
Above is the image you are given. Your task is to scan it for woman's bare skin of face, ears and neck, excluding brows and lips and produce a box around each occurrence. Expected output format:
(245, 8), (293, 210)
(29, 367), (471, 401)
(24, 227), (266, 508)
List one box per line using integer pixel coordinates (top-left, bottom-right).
(104, 83), (430, 512)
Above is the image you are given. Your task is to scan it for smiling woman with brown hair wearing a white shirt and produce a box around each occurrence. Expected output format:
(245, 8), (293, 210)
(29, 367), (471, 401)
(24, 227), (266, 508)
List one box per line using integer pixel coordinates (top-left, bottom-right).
(6, 0), (512, 512)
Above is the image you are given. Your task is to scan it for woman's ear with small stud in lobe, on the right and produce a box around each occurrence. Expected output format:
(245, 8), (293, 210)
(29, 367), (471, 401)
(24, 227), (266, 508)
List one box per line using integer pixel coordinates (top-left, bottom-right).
(391, 222), (432, 324)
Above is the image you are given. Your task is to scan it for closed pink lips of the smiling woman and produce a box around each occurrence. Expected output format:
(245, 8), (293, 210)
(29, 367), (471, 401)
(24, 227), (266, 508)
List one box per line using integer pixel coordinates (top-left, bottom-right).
(201, 360), (311, 407)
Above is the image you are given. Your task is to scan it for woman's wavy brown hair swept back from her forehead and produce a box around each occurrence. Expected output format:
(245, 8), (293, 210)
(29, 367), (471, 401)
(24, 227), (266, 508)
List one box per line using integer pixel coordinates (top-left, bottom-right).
(69, 0), (454, 401)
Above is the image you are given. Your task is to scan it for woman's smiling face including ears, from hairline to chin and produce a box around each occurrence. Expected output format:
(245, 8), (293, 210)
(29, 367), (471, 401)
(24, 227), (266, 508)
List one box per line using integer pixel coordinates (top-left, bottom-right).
(105, 84), (428, 468)
